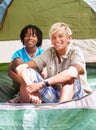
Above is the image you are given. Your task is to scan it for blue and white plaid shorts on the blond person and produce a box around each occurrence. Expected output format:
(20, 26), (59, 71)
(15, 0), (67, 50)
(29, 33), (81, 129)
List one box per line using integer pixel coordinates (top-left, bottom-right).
(27, 69), (84, 103)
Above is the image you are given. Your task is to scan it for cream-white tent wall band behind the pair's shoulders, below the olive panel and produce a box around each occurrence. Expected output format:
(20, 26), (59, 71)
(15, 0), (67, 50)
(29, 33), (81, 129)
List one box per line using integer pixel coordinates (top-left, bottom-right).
(0, 38), (96, 63)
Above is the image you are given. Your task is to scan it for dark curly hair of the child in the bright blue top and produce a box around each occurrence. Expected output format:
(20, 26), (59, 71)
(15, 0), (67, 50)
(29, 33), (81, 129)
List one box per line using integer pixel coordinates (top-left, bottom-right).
(20, 24), (43, 47)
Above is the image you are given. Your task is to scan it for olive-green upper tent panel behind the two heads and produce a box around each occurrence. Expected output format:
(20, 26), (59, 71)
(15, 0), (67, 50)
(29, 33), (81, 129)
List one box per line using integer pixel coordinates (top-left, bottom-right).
(0, 0), (96, 41)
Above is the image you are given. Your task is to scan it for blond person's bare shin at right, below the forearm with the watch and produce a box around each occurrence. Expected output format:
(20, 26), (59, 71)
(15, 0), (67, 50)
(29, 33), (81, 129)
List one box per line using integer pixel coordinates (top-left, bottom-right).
(59, 84), (74, 102)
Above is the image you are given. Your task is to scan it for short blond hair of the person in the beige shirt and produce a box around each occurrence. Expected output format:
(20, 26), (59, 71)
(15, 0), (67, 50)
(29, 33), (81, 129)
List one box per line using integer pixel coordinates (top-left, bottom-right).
(49, 22), (72, 38)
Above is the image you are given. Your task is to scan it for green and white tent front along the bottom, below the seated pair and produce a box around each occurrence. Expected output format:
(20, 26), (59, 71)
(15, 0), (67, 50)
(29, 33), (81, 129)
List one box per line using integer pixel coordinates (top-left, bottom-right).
(0, 91), (96, 130)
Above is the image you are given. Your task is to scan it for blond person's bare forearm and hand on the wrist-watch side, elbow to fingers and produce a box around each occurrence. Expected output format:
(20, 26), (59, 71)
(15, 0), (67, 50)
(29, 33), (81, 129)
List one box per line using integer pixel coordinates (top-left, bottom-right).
(20, 65), (83, 93)
